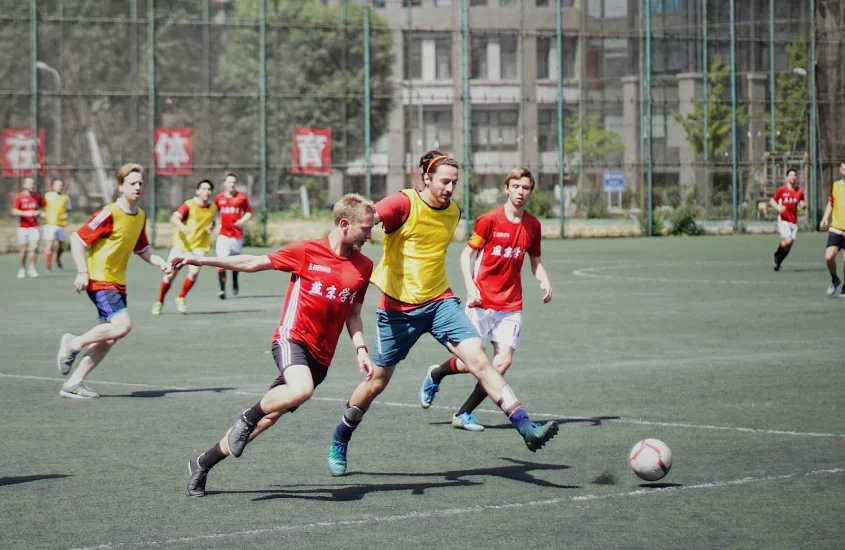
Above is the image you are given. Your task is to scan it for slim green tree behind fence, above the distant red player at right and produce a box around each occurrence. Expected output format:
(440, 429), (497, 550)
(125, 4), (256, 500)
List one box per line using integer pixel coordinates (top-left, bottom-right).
(766, 39), (809, 152)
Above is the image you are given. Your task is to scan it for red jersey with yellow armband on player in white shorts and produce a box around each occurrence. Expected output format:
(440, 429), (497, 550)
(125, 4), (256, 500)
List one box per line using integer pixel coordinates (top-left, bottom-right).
(467, 205), (541, 311)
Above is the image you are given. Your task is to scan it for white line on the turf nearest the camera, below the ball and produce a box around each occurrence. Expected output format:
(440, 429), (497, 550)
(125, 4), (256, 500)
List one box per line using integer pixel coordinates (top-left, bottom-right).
(67, 468), (845, 550)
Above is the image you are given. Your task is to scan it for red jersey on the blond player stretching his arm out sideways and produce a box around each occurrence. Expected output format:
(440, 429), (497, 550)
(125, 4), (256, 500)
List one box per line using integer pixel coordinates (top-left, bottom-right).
(269, 237), (373, 366)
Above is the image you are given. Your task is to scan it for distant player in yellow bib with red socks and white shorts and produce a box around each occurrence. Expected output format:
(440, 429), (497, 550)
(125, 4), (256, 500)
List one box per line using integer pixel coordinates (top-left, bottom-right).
(153, 180), (217, 315)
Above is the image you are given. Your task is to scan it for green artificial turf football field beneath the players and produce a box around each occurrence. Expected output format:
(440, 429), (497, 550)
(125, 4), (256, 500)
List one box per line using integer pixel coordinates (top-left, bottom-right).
(0, 234), (845, 549)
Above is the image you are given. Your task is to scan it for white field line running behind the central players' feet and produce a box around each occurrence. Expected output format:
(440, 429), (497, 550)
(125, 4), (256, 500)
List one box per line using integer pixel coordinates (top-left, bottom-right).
(0, 373), (845, 438)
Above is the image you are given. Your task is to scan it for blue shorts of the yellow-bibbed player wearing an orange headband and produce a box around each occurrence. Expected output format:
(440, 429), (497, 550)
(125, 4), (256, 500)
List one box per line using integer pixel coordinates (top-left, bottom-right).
(373, 297), (480, 367)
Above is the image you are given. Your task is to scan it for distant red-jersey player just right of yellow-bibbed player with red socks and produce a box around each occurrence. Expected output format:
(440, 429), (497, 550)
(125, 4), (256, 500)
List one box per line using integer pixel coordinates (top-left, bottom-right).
(214, 172), (252, 300)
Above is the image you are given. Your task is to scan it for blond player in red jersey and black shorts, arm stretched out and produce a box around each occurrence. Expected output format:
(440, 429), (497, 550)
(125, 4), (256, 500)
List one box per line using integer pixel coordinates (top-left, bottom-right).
(182, 194), (375, 497)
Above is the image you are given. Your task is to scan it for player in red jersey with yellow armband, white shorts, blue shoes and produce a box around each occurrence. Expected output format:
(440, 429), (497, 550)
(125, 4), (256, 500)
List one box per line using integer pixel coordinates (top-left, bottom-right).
(423, 168), (552, 432)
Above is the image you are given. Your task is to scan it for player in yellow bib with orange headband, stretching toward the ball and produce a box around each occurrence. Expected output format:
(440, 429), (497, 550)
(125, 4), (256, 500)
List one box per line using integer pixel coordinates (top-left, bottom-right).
(328, 151), (558, 476)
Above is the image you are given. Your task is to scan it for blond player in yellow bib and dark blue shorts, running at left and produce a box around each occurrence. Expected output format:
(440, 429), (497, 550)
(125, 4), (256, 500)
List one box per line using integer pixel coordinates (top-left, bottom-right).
(56, 164), (170, 399)
